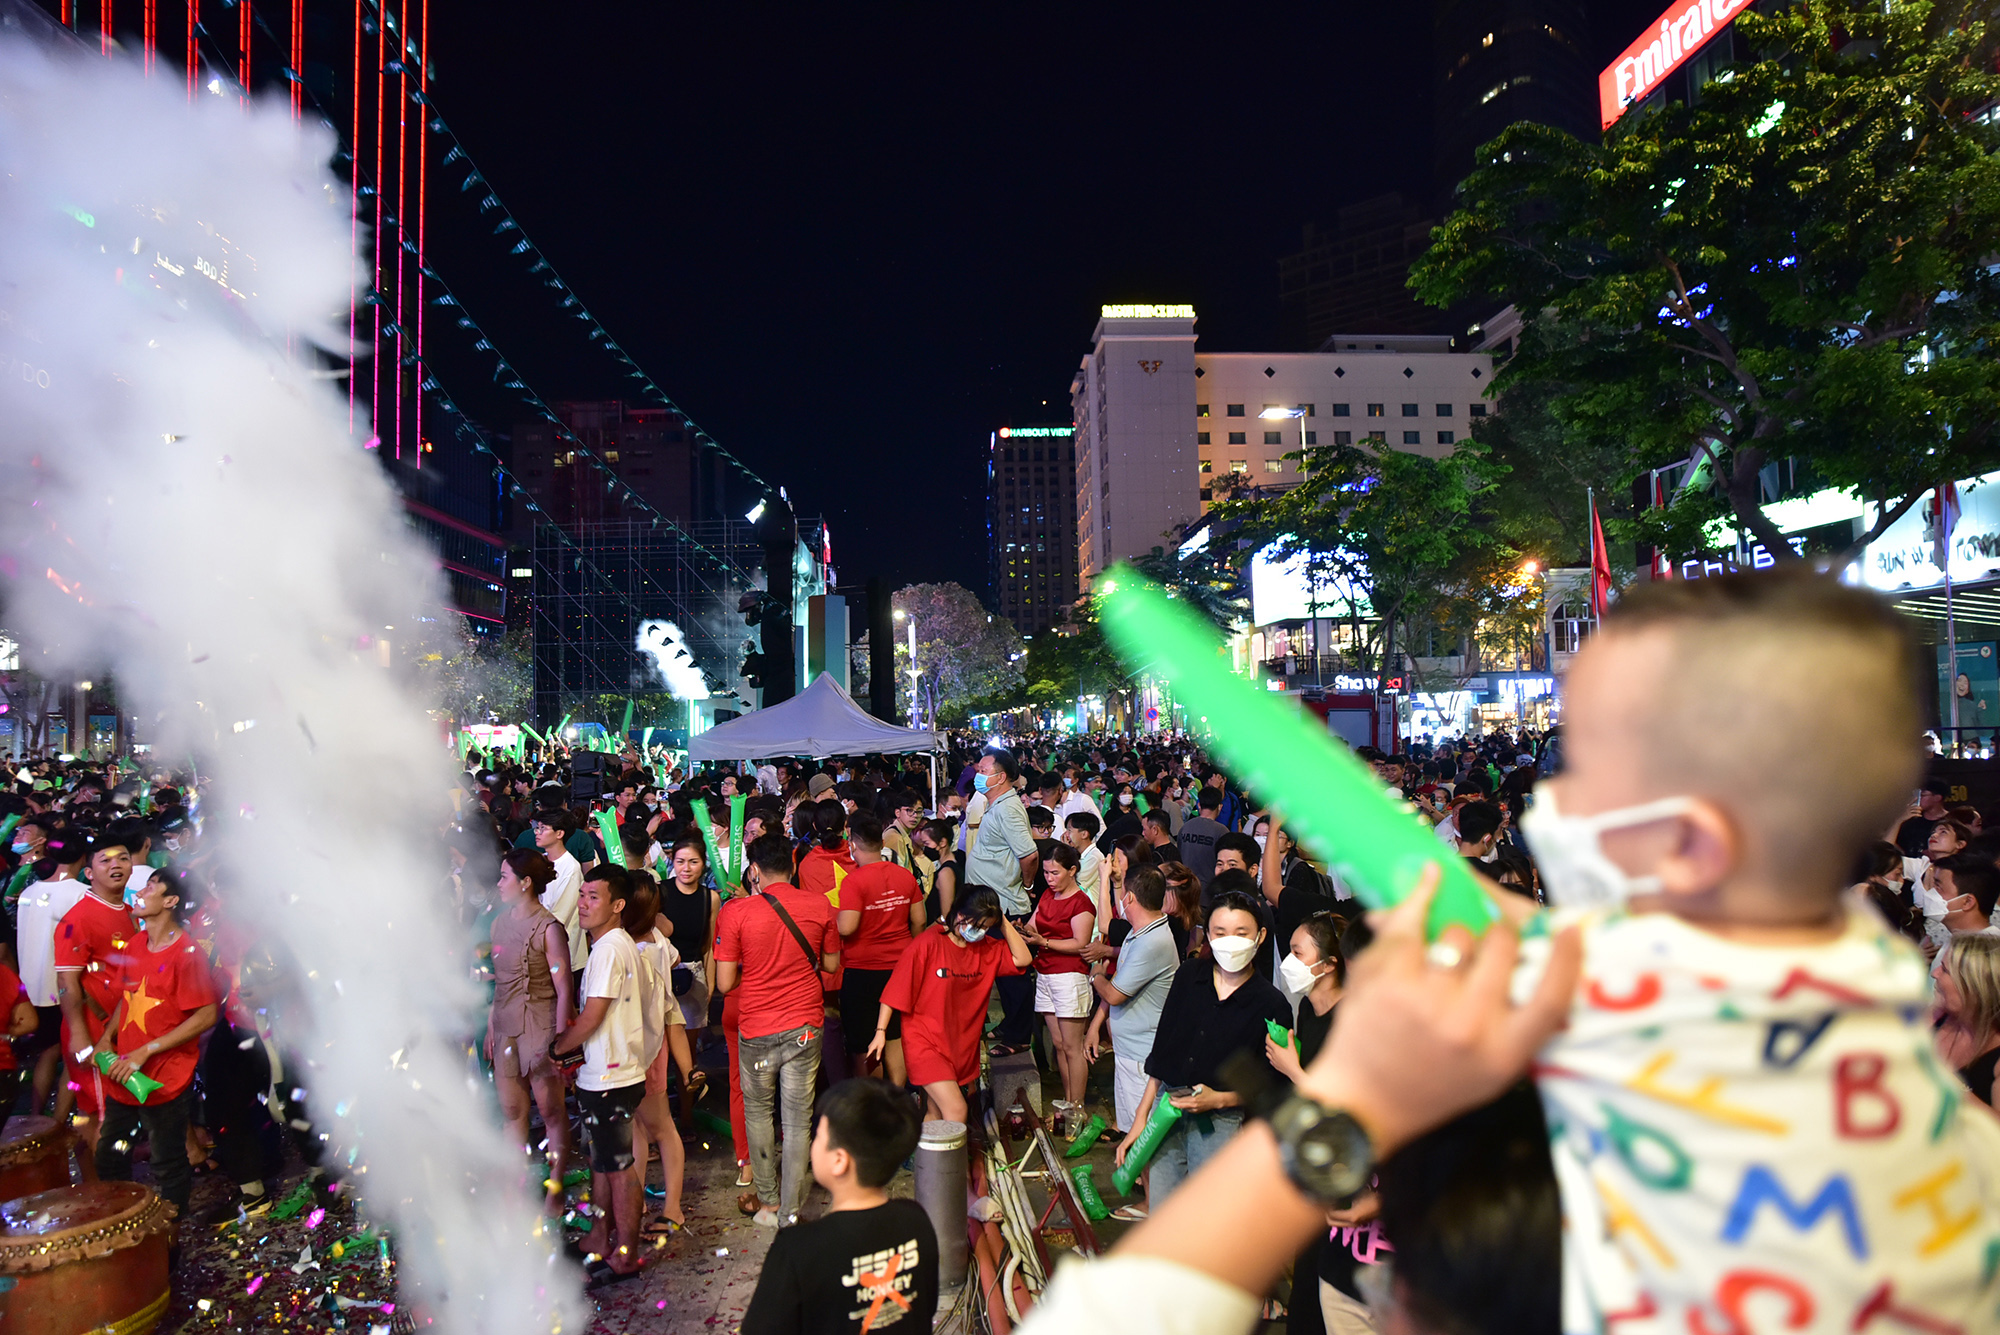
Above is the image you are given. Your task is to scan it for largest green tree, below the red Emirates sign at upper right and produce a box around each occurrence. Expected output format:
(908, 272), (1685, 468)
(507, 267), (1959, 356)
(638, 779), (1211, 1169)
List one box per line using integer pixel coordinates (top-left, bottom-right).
(1412, 0), (2000, 560)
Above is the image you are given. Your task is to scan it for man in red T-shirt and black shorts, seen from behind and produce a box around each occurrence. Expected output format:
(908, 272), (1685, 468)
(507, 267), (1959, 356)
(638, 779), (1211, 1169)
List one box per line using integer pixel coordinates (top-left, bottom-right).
(834, 811), (924, 1085)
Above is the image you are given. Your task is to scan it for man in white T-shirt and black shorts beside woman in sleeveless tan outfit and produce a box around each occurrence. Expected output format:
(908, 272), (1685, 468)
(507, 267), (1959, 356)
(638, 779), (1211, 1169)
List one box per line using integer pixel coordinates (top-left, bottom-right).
(548, 863), (646, 1285)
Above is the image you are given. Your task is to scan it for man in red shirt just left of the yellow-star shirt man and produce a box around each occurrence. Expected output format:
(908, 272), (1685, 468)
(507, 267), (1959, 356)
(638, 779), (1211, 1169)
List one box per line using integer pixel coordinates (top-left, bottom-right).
(54, 835), (139, 1153)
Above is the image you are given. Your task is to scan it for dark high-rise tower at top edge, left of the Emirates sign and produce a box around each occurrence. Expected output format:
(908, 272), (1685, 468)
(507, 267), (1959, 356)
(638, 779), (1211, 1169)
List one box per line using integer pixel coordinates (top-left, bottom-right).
(1430, 0), (1598, 201)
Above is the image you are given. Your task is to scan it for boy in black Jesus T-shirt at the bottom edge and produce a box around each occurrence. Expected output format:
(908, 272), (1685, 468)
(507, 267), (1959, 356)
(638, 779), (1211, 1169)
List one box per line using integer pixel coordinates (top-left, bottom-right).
(742, 1079), (938, 1335)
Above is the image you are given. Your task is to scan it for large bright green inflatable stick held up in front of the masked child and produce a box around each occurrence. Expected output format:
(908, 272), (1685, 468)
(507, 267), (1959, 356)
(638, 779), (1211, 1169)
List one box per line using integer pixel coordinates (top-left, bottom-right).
(1098, 564), (1498, 943)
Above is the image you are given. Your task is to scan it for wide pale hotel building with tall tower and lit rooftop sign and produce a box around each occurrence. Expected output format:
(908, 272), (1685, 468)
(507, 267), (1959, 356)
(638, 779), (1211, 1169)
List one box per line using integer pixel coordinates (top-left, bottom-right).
(1070, 306), (1494, 582)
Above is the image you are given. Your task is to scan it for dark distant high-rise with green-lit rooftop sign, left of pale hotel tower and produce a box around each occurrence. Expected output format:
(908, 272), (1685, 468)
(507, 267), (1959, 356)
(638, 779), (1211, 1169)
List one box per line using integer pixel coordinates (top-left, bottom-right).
(986, 426), (1076, 636)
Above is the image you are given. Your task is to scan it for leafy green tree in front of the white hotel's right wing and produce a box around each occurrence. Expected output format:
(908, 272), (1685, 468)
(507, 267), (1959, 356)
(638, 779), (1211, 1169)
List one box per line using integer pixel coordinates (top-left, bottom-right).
(1212, 442), (1514, 675)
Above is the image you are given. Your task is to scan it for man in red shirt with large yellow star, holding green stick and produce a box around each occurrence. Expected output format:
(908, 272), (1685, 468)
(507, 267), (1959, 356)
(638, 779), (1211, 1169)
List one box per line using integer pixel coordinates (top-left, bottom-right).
(90, 871), (222, 1213)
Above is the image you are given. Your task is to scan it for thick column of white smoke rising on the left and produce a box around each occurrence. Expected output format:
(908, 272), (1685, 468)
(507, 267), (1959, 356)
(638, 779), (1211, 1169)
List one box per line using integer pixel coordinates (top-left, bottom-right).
(0, 40), (584, 1335)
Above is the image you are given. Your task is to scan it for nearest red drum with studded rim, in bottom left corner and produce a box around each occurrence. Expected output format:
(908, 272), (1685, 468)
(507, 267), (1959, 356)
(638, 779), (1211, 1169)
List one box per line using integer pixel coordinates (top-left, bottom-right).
(0, 1181), (174, 1335)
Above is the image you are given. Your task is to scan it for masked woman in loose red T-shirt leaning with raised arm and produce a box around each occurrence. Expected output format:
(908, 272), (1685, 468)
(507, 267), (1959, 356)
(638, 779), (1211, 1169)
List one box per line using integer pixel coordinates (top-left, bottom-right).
(868, 885), (1034, 1123)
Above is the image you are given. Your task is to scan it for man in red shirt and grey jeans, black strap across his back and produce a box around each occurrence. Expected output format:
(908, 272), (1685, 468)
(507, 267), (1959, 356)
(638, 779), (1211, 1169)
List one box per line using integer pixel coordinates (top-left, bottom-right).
(716, 833), (840, 1229)
